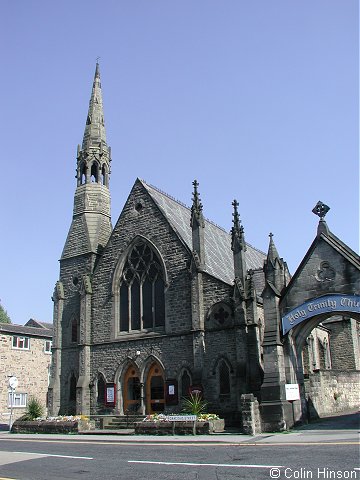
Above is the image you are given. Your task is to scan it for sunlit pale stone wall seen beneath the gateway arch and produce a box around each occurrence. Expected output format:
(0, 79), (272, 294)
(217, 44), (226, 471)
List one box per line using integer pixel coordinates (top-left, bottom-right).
(304, 370), (360, 419)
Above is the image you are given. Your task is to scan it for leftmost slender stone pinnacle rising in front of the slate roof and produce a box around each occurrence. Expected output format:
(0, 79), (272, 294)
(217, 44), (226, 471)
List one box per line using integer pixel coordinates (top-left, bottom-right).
(190, 180), (205, 269)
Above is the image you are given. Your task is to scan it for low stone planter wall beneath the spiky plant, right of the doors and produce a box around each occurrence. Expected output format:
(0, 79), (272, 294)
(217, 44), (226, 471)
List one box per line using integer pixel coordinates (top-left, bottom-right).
(135, 419), (225, 435)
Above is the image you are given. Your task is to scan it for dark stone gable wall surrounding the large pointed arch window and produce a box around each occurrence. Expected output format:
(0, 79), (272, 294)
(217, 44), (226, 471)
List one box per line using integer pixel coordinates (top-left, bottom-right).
(92, 179), (191, 343)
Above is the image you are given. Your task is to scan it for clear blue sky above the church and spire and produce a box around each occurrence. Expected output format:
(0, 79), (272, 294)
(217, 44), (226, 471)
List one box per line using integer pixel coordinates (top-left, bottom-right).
(0, 0), (359, 324)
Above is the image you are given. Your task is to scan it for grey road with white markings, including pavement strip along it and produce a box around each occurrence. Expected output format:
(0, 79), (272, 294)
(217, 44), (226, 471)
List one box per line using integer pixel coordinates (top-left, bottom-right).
(0, 410), (360, 480)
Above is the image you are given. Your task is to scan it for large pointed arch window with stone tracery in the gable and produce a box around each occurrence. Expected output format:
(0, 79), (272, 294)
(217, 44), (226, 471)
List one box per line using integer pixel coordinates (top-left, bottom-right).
(119, 242), (165, 332)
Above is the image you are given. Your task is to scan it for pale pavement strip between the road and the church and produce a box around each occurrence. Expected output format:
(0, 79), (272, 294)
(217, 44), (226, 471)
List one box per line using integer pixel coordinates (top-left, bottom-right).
(0, 411), (360, 445)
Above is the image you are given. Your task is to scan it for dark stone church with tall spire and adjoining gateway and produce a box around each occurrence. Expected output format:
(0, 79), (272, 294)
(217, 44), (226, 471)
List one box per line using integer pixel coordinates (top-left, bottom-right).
(49, 64), (360, 428)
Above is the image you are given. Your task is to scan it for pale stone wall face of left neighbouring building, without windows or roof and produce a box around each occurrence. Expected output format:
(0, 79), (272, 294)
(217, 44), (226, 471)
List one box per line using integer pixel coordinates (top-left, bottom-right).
(0, 332), (51, 425)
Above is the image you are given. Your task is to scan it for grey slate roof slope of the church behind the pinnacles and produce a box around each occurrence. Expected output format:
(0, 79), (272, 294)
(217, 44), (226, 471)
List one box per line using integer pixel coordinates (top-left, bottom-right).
(140, 180), (266, 284)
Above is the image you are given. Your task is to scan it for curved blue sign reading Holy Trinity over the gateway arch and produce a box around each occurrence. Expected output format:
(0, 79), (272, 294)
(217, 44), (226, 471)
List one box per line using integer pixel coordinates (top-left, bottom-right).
(281, 295), (360, 335)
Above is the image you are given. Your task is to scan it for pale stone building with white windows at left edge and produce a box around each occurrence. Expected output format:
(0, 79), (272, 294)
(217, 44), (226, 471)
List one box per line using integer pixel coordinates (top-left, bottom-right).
(0, 319), (53, 426)
